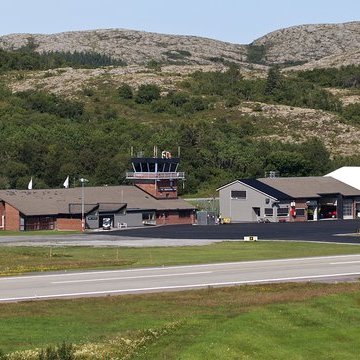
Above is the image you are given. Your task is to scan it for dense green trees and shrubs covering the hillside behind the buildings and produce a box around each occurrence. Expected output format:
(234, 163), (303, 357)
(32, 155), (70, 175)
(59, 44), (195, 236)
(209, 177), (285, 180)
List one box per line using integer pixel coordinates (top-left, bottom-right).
(0, 58), (360, 195)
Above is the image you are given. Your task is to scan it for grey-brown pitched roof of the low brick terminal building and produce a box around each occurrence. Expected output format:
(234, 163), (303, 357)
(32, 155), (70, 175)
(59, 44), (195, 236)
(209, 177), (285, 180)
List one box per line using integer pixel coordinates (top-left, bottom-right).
(0, 185), (194, 216)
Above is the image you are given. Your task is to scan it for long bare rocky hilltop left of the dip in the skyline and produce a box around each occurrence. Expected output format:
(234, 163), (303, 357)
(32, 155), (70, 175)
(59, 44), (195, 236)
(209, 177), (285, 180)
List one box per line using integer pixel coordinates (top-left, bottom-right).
(0, 29), (247, 65)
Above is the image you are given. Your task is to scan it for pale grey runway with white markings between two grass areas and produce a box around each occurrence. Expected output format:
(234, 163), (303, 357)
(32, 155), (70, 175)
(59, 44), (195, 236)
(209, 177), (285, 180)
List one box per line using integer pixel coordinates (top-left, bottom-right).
(0, 255), (360, 302)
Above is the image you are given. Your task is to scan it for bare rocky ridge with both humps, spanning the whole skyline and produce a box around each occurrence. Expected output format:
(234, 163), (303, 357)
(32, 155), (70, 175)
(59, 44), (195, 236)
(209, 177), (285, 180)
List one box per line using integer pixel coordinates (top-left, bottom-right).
(0, 22), (360, 68)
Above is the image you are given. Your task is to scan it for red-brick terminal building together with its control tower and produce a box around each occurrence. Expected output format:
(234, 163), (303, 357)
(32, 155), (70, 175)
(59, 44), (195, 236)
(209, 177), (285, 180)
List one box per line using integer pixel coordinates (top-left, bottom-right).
(0, 151), (195, 231)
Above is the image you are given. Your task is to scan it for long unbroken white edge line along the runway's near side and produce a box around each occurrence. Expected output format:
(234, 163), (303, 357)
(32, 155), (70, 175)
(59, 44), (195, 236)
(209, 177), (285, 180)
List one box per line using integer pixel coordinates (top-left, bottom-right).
(0, 272), (360, 301)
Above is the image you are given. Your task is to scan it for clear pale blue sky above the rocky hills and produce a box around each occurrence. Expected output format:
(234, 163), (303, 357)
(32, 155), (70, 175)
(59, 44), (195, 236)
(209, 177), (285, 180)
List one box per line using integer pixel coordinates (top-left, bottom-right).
(0, 0), (360, 44)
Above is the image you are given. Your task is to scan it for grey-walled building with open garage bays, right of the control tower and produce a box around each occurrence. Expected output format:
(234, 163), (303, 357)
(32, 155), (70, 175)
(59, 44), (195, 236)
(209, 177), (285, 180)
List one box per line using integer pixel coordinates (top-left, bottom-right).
(217, 176), (360, 222)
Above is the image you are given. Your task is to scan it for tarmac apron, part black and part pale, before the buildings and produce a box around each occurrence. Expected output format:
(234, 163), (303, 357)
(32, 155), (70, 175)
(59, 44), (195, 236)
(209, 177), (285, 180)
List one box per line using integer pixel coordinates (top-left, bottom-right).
(0, 219), (360, 247)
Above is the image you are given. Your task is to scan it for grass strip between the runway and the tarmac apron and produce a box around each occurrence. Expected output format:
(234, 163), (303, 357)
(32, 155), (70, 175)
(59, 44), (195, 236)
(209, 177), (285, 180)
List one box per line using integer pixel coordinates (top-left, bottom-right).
(0, 241), (360, 275)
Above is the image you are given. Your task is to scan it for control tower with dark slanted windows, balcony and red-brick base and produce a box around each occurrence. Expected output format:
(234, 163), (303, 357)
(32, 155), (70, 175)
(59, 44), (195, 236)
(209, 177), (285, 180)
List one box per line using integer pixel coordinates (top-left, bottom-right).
(126, 148), (185, 199)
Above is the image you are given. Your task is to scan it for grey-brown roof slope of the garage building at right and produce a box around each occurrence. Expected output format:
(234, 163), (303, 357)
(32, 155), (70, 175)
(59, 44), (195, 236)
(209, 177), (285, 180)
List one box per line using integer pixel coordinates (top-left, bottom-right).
(258, 176), (360, 199)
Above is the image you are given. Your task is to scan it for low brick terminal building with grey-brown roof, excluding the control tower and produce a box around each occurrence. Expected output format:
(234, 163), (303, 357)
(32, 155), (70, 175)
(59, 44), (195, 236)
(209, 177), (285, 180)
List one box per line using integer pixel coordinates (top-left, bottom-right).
(0, 185), (195, 231)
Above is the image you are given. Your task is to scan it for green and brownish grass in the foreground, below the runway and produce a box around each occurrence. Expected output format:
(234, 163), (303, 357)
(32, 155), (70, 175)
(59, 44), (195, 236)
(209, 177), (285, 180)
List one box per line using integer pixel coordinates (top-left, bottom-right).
(0, 283), (360, 360)
